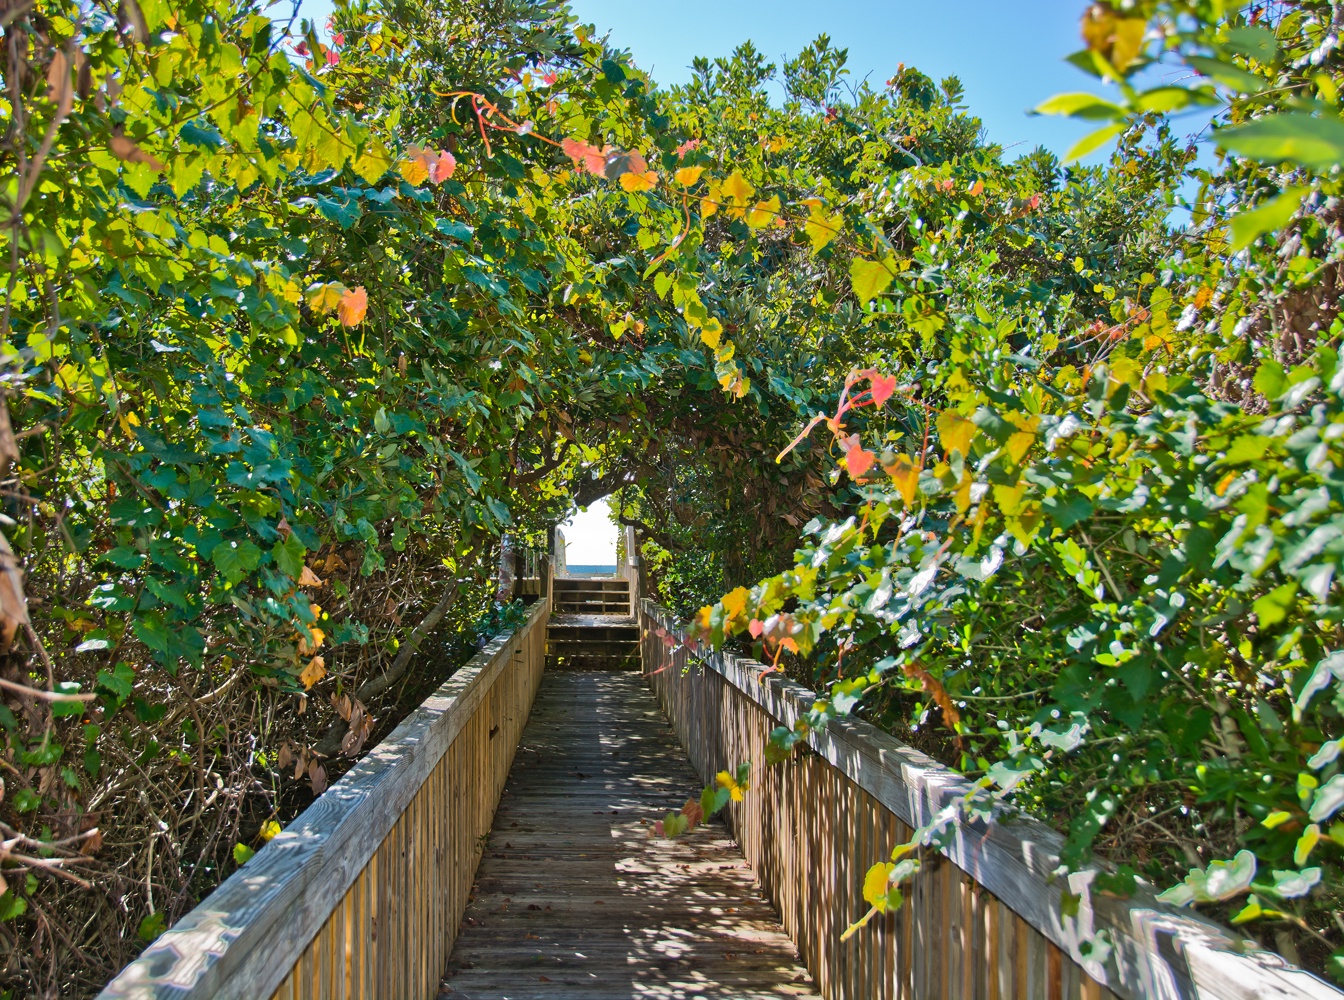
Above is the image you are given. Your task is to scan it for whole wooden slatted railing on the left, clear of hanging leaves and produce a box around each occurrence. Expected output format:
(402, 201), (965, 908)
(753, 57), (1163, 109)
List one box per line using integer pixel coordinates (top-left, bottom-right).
(99, 598), (550, 1000)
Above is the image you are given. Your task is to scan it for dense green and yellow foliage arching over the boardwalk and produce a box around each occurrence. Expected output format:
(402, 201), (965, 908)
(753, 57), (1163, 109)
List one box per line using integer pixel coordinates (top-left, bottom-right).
(0, 0), (1344, 996)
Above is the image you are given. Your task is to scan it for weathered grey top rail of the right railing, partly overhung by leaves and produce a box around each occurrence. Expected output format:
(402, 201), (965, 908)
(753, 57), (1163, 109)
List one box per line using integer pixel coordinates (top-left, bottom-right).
(640, 598), (1344, 1000)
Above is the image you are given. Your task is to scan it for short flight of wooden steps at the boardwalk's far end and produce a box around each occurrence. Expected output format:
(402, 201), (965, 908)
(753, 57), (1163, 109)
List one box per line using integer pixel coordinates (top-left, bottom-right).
(546, 577), (640, 671)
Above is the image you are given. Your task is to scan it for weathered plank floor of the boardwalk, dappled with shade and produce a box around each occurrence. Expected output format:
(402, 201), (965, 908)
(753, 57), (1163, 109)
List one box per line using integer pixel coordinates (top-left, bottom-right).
(439, 672), (818, 1000)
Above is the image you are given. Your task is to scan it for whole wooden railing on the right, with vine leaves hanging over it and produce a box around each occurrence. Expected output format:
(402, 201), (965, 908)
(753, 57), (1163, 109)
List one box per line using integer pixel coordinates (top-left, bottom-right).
(640, 599), (1344, 1000)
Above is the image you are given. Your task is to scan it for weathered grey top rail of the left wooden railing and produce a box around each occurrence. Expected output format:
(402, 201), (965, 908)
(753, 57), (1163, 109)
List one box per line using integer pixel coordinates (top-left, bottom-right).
(98, 601), (547, 1000)
